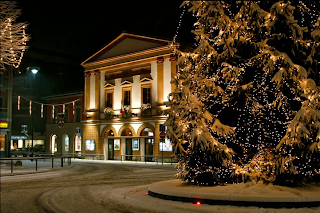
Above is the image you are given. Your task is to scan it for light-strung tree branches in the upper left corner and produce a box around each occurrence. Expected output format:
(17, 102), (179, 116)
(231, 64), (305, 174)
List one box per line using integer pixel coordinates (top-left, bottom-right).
(0, 1), (28, 73)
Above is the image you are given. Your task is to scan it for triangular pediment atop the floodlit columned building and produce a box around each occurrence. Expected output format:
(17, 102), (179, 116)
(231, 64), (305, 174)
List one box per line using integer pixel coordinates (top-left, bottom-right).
(82, 33), (170, 64)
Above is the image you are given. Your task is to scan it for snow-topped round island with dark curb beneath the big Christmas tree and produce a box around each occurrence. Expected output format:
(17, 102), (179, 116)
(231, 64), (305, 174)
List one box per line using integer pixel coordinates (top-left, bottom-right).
(148, 180), (320, 209)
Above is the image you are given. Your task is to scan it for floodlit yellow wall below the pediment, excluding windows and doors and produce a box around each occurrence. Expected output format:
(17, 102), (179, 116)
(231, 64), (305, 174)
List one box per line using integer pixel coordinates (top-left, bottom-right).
(82, 34), (177, 160)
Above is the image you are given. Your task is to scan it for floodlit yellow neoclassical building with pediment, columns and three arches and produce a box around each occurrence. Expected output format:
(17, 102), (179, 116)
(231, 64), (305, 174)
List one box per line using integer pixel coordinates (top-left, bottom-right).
(81, 33), (182, 161)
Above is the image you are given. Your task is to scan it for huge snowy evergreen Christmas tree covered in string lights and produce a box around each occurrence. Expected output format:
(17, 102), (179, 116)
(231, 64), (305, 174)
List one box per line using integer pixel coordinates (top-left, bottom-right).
(166, 1), (320, 185)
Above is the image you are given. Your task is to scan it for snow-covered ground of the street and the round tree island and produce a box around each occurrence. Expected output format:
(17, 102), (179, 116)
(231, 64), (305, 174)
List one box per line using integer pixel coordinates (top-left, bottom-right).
(0, 160), (320, 213)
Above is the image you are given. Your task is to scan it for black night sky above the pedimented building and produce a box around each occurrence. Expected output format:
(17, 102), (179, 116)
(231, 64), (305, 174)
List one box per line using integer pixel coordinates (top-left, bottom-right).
(18, 1), (194, 95)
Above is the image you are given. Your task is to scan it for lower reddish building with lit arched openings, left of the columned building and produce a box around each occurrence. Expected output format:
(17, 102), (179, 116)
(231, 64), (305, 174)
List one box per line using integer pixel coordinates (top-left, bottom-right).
(43, 92), (84, 156)
